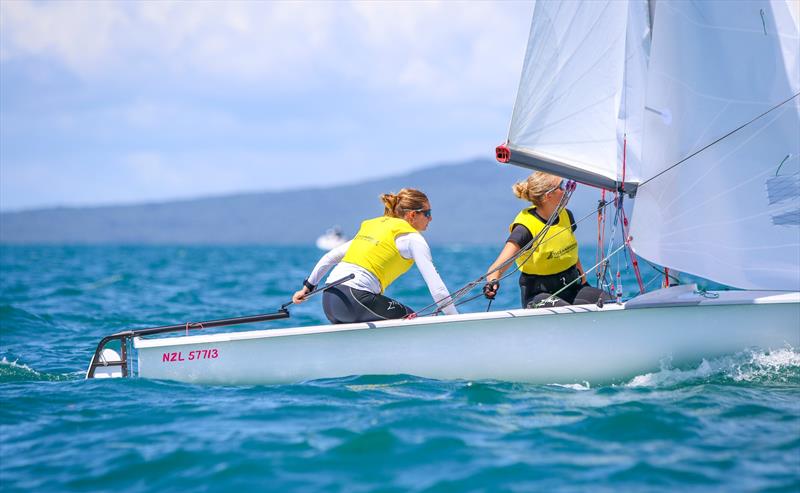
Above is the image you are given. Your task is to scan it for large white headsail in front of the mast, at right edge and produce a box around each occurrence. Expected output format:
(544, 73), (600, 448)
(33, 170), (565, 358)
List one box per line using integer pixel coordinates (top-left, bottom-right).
(632, 0), (800, 290)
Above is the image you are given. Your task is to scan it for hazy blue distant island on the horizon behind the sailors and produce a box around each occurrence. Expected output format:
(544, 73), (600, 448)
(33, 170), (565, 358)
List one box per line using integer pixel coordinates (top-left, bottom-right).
(0, 159), (598, 246)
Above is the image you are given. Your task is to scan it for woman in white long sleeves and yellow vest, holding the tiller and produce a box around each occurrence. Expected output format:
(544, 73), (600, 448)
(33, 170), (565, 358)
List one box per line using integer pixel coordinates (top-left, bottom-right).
(292, 188), (458, 324)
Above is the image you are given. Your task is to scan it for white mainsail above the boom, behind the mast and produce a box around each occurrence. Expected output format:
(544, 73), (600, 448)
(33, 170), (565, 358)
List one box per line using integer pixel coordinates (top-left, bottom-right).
(507, 0), (650, 189)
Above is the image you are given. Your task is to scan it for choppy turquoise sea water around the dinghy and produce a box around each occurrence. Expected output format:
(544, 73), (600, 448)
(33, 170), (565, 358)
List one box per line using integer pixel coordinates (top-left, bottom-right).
(0, 246), (800, 492)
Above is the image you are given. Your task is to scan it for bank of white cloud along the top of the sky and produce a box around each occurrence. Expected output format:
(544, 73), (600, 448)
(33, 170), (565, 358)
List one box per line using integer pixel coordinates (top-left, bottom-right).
(0, 0), (530, 99)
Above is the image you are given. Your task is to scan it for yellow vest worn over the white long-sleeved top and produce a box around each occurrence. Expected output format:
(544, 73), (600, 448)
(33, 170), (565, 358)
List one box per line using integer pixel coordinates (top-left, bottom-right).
(342, 216), (417, 292)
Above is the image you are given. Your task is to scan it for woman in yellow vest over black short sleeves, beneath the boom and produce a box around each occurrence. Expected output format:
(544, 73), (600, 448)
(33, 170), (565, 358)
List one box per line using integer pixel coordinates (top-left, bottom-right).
(483, 171), (609, 308)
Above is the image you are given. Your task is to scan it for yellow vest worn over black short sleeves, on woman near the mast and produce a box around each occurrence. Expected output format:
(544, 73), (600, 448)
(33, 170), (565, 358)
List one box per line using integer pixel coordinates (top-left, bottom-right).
(509, 206), (578, 276)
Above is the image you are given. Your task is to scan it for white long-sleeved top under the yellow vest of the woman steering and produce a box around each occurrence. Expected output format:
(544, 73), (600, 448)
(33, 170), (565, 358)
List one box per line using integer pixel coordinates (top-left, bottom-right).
(308, 233), (458, 315)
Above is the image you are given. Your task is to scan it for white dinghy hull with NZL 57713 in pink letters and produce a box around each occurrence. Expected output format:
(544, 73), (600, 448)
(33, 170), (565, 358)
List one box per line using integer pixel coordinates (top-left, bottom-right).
(134, 286), (800, 385)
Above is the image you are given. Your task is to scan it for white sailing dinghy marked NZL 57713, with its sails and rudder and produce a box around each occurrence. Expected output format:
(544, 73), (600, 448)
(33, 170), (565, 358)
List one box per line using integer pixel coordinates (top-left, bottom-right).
(87, 0), (800, 385)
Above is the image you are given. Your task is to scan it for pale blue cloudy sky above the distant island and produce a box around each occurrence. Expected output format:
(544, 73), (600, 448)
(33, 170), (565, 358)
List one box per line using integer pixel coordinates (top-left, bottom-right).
(0, 0), (533, 211)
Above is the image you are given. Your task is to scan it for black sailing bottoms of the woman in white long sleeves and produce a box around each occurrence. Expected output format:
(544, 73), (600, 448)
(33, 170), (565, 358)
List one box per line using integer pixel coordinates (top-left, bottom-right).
(322, 285), (414, 324)
